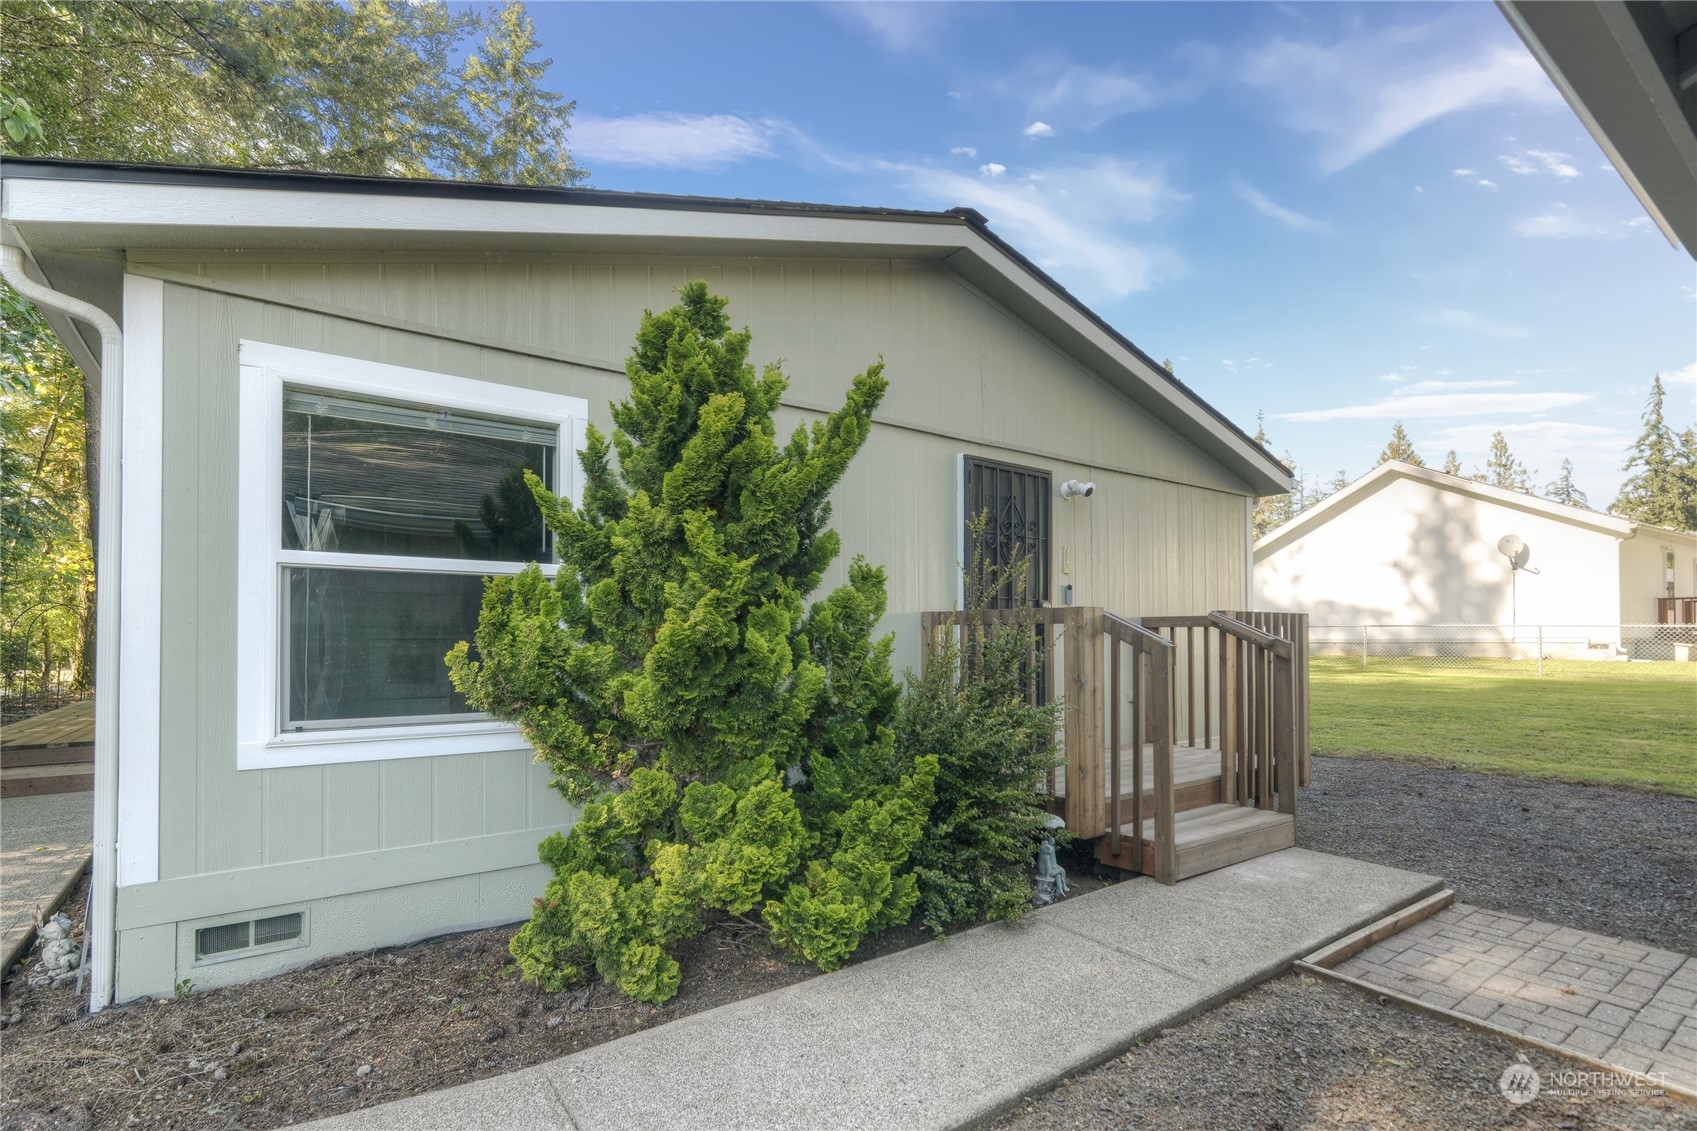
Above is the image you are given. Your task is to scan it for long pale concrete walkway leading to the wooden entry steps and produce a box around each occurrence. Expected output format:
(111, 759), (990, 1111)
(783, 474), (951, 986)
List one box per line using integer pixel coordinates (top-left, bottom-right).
(305, 849), (1441, 1131)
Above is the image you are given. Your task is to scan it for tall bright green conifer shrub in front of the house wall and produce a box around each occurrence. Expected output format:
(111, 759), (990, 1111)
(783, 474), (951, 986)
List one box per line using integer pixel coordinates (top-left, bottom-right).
(448, 282), (937, 1002)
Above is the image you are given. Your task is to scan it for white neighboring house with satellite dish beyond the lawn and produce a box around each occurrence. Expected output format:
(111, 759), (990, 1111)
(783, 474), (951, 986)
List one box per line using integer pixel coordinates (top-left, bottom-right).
(1254, 460), (1697, 627)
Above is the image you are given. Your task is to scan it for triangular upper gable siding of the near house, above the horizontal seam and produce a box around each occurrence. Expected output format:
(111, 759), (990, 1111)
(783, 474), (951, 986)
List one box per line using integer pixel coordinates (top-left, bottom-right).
(179, 258), (1242, 491)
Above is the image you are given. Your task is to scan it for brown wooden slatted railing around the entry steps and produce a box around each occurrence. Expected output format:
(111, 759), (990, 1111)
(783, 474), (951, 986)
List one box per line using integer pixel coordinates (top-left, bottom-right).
(920, 606), (1308, 878)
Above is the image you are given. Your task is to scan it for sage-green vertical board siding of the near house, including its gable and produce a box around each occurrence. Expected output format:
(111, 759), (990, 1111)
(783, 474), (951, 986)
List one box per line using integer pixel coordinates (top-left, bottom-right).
(160, 258), (1244, 878)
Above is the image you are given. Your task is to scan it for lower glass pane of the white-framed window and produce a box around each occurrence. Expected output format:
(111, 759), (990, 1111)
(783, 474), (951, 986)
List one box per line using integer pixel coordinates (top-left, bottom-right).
(283, 569), (484, 730)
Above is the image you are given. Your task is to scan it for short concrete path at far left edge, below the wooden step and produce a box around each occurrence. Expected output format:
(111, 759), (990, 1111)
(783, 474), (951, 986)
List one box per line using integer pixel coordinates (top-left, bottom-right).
(0, 793), (95, 971)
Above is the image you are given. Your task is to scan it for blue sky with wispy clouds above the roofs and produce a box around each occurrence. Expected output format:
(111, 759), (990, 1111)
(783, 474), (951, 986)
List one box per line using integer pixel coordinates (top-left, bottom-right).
(531, 0), (1697, 506)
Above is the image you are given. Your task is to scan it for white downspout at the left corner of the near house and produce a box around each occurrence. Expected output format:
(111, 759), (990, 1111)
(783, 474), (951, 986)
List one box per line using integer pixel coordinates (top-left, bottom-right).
(0, 245), (124, 1012)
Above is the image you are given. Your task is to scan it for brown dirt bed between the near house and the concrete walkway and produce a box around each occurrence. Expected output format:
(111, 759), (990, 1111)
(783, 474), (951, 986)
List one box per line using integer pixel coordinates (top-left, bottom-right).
(0, 861), (1105, 1131)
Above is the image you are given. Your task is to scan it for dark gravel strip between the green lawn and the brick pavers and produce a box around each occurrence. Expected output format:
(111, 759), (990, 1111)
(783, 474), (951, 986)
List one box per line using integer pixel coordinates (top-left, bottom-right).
(1297, 754), (1697, 954)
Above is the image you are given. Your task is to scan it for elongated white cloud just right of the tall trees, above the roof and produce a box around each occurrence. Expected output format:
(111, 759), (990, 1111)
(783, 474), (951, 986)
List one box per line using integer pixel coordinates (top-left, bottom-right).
(572, 112), (792, 172)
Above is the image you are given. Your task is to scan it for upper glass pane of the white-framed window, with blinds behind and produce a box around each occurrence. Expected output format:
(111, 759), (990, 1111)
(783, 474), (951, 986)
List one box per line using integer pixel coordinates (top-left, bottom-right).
(282, 389), (558, 562)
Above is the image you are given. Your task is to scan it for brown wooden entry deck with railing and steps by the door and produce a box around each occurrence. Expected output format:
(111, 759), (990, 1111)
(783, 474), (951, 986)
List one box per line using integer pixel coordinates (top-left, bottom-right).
(920, 606), (1308, 883)
